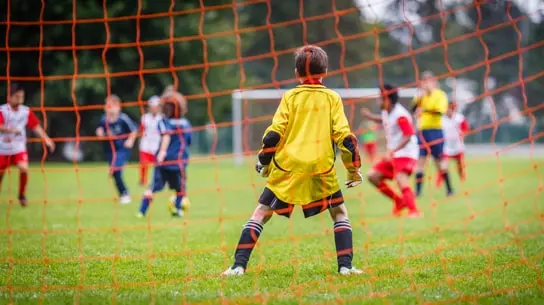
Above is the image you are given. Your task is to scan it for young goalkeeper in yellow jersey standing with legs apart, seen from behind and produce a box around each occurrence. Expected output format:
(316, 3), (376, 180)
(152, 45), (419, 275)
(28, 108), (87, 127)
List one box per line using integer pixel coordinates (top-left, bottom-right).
(223, 46), (363, 276)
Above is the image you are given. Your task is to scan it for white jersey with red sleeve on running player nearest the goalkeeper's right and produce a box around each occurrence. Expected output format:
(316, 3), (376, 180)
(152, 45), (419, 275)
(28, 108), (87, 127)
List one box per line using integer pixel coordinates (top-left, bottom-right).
(382, 103), (419, 159)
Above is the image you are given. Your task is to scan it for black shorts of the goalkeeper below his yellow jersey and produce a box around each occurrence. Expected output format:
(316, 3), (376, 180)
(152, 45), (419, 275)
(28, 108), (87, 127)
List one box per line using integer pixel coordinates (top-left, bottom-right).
(259, 187), (344, 218)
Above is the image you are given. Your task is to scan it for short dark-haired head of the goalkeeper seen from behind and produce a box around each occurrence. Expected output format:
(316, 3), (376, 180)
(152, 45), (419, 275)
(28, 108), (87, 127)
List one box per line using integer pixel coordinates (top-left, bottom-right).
(295, 45), (329, 77)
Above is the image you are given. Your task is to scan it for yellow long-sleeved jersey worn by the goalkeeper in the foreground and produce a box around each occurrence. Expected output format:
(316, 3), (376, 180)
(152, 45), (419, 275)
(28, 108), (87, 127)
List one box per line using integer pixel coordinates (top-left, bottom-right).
(263, 85), (360, 205)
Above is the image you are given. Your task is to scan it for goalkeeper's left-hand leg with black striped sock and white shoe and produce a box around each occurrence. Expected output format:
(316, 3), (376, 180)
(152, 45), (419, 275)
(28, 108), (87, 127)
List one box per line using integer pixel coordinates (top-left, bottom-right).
(223, 203), (274, 275)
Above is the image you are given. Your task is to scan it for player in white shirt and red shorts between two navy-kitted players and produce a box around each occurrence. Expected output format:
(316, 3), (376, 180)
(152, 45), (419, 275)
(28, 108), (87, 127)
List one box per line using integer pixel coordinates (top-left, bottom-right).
(140, 95), (163, 185)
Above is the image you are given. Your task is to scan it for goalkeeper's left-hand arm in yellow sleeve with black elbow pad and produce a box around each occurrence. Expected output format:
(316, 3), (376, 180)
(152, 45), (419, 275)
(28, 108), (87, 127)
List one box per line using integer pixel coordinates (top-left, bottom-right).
(257, 96), (289, 173)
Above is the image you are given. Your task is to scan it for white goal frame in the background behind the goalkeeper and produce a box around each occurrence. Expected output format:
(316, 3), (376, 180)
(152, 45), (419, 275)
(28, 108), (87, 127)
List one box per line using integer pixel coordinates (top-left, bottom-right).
(232, 88), (417, 164)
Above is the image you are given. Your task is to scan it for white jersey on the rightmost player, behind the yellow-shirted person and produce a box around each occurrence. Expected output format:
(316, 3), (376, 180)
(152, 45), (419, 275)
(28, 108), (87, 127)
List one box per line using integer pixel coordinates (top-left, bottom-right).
(442, 112), (468, 156)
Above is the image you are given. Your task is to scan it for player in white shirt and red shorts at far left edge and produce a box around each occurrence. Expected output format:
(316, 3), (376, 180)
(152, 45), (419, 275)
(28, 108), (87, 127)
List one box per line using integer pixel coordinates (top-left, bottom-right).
(0, 83), (55, 207)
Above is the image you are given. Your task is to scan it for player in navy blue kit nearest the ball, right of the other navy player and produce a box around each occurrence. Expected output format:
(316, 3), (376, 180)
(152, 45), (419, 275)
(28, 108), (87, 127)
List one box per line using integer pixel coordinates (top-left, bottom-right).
(138, 99), (191, 218)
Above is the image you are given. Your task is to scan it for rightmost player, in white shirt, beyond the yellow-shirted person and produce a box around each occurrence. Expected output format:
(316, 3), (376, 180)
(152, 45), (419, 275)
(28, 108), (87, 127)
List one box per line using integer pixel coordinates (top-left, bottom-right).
(437, 103), (470, 186)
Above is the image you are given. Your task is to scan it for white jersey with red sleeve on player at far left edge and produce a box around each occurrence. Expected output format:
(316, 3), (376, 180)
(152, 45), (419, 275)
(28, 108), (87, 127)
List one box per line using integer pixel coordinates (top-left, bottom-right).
(0, 104), (40, 156)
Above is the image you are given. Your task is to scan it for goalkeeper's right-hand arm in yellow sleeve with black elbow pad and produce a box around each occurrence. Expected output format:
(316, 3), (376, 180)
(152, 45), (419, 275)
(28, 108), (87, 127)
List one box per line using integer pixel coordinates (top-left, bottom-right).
(331, 98), (363, 187)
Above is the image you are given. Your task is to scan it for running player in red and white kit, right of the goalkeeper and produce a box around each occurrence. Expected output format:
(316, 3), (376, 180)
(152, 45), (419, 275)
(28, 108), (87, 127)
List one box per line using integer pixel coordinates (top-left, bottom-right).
(362, 85), (421, 217)
